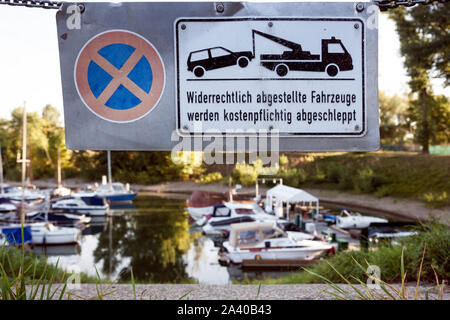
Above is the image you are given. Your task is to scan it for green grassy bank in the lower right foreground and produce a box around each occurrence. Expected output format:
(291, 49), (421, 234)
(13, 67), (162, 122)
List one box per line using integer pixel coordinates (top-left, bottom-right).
(244, 222), (450, 284)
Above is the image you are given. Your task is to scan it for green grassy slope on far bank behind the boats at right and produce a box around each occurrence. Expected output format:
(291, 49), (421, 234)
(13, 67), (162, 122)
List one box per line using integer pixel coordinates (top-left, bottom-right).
(280, 151), (450, 206)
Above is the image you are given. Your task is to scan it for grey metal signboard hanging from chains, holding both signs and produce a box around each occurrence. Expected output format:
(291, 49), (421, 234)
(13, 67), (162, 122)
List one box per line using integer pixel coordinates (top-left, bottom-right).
(57, 2), (379, 151)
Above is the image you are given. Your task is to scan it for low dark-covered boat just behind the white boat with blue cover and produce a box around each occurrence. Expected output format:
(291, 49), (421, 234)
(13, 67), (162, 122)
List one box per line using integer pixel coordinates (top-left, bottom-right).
(25, 211), (91, 226)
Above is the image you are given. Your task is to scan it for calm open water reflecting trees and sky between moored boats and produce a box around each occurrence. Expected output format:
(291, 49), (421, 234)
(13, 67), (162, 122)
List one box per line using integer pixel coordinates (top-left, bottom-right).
(40, 196), (237, 284)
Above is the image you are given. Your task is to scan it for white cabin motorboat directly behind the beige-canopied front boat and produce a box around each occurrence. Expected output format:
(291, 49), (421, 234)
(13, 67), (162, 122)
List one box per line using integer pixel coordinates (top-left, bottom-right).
(201, 202), (285, 235)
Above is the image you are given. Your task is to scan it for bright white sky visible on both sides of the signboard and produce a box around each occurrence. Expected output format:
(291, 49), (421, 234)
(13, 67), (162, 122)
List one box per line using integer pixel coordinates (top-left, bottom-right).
(0, 0), (450, 119)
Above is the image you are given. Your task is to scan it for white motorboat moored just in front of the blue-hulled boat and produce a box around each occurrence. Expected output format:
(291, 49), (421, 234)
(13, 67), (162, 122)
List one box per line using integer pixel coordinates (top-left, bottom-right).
(51, 193), (108, 216)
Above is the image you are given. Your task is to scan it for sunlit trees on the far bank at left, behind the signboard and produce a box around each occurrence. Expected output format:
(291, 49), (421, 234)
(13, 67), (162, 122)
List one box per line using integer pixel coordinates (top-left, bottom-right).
(0, 105), (204, 184)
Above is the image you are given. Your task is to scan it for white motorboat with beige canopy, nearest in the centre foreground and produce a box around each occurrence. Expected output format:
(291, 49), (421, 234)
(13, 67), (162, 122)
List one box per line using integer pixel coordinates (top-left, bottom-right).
(219, 222), (333, 265)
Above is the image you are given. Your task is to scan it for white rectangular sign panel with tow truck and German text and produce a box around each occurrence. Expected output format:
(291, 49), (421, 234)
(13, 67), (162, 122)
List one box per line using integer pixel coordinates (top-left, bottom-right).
(175, 17), (367, 137)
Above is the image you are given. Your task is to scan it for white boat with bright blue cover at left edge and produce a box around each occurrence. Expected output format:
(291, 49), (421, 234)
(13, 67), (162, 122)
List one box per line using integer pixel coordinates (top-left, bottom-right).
(2, 222), (81, 245)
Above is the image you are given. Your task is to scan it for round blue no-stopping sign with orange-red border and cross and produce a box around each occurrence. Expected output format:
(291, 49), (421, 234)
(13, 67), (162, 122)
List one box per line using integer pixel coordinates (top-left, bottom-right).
(74, 30), (165, 122)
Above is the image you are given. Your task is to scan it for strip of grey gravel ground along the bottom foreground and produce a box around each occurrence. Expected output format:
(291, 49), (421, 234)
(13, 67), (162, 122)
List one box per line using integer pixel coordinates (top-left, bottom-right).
(61, 284), (450, 300)
